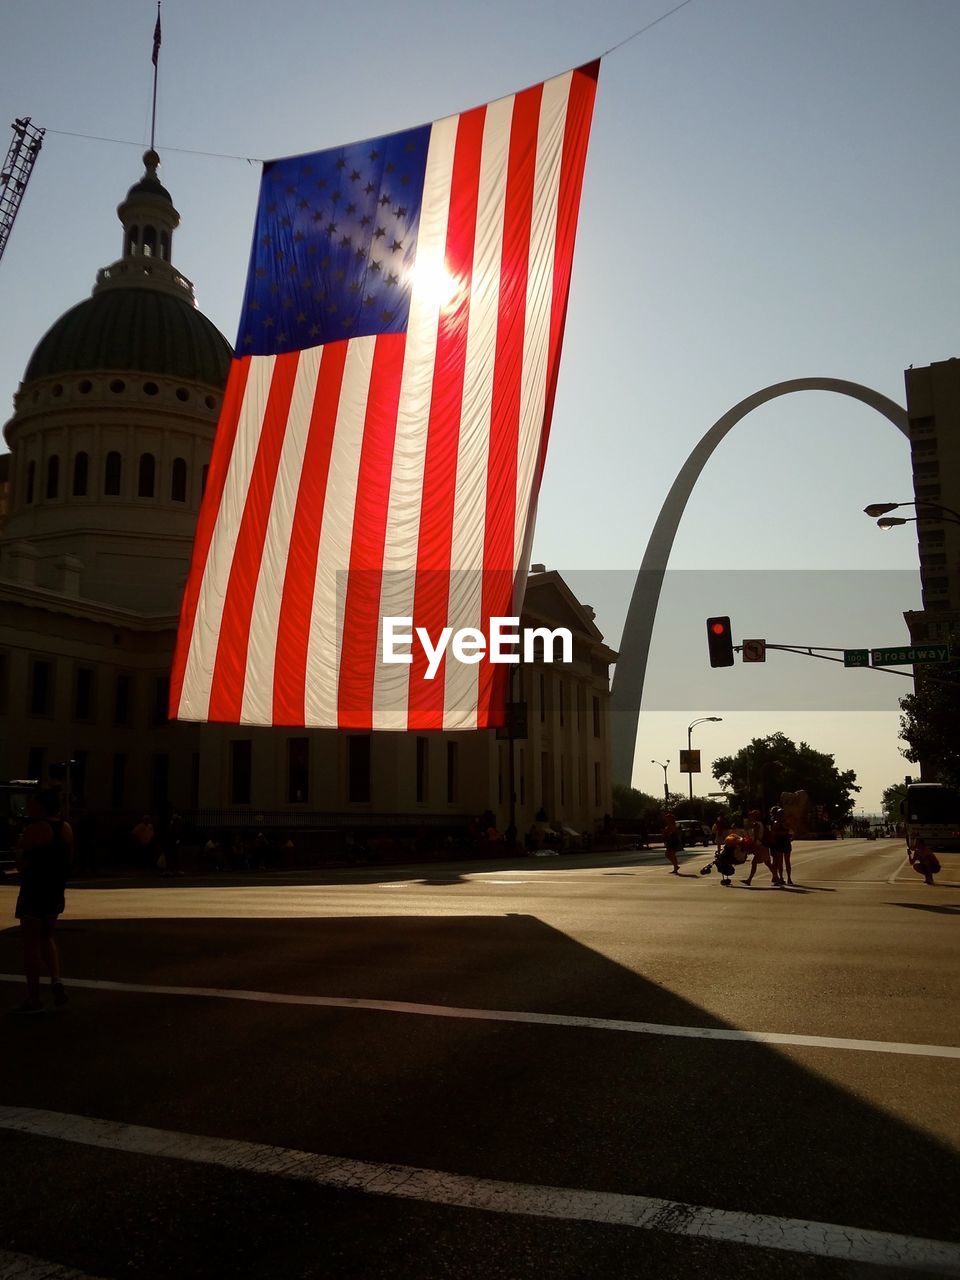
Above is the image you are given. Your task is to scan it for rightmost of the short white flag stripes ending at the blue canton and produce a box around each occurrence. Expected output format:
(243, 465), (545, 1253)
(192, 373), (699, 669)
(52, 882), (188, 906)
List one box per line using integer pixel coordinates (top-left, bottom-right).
(303, 335), (376, 728)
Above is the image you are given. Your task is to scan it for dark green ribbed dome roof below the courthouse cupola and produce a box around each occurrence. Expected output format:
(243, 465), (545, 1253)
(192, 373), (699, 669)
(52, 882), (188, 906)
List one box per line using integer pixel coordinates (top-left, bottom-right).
(23, 288), (233, 389)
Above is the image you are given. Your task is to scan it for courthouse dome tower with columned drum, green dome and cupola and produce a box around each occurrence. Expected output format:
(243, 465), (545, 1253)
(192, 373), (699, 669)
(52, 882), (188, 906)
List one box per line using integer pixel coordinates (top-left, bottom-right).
(0, 151), (230, 613)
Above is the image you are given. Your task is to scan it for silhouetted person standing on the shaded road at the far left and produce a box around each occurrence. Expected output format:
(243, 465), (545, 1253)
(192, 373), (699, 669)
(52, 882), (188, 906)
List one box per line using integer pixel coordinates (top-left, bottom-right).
(15, 791), (73, 1014)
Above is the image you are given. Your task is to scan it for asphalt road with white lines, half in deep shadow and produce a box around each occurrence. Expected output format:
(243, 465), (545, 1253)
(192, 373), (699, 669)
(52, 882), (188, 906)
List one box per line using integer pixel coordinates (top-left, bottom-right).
(0, 841), (960, 1280)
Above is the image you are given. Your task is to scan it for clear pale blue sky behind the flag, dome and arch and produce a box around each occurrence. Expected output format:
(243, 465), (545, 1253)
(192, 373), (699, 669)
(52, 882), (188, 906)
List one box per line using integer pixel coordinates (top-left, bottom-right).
(0, 0), (960, 809)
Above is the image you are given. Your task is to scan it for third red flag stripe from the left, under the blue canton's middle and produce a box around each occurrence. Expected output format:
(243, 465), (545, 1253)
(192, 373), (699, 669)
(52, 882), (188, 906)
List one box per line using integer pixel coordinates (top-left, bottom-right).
(273, 342), (349, 724)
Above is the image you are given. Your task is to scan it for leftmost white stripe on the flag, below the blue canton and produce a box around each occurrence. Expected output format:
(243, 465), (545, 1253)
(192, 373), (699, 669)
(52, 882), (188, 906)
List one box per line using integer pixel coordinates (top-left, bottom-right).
(178, 356), (276, 721)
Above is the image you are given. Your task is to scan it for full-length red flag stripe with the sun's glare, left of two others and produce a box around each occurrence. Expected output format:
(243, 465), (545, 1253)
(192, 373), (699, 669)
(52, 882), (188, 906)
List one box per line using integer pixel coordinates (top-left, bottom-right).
(407, 106), (486, 730)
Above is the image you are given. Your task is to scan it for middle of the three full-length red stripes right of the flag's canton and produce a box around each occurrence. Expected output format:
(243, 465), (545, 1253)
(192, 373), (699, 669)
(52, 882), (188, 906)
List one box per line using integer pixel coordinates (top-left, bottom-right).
(476, 84), (543, 728)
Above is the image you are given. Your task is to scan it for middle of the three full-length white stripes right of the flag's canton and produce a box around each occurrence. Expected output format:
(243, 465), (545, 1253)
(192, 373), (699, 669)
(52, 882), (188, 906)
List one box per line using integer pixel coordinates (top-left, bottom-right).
(443, 95), (513, 730)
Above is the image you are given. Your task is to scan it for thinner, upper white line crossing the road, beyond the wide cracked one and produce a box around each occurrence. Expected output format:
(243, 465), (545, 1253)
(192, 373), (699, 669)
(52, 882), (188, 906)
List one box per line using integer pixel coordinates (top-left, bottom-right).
(0, 973), (960, 1060)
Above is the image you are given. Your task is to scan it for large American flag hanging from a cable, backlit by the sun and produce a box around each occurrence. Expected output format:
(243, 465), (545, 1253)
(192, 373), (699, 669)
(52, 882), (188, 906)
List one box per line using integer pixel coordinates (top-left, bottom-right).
(170, 63), (599, 730)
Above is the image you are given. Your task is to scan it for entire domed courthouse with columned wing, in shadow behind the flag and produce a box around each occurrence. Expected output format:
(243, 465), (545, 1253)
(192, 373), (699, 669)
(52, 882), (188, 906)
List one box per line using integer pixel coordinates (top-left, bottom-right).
(0, 151), (616, 831)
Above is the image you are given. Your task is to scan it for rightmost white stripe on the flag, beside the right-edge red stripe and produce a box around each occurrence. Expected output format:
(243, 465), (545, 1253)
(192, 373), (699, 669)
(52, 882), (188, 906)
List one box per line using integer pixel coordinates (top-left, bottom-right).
(513, 72), (573, 578)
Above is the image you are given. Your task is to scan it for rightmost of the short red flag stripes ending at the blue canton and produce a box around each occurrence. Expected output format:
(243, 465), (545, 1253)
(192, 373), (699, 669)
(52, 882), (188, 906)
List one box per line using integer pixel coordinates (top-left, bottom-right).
(337, 334), (407, 728)
